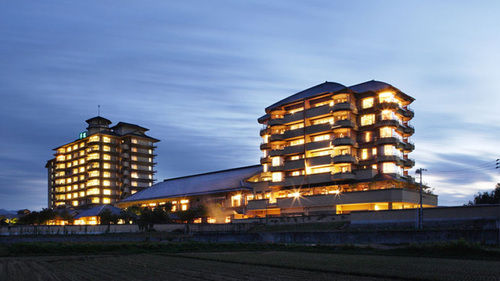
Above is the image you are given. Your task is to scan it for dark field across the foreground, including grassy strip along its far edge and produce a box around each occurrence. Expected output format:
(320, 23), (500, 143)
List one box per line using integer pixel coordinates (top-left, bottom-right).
(0, 243), (500, 281)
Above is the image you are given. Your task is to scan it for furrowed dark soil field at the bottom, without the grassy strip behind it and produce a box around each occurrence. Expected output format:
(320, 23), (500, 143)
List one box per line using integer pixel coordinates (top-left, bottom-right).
(0, 251), (500, 281)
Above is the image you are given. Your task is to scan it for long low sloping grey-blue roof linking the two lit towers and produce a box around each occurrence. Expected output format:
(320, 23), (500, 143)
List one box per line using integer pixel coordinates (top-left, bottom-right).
(121, 165), (262, 202)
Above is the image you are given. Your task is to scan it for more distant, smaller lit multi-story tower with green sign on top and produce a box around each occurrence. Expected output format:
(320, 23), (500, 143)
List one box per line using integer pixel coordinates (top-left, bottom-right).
(46, 116), (159, 208)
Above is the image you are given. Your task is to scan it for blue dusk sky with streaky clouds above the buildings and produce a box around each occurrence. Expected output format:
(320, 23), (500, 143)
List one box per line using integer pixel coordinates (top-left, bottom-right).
(0, 0), (500, 210)
